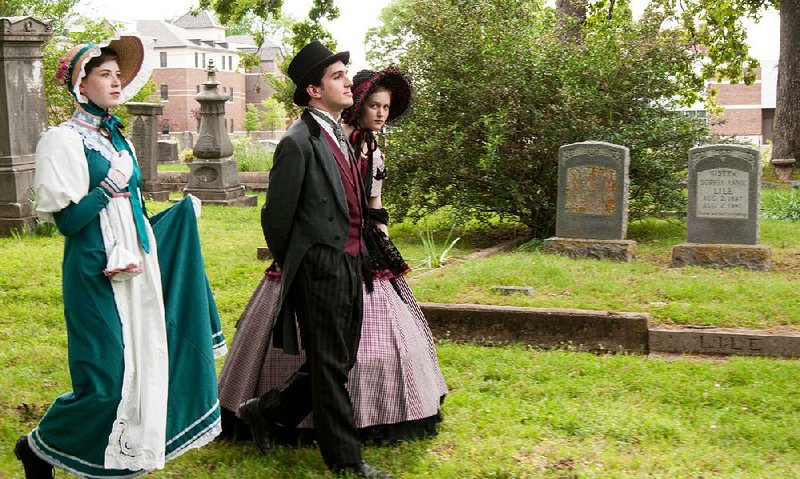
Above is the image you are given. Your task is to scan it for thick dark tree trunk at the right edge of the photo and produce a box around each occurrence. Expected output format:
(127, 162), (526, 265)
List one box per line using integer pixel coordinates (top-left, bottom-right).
(772, 0), (800, 167)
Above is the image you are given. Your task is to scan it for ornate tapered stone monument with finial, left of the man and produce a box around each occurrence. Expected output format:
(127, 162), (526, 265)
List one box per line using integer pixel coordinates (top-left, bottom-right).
(183, 60), (258, 206)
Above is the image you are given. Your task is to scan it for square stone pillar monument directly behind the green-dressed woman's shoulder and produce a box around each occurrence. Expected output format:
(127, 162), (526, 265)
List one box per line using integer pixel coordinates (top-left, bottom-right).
(125, 102), (169, 201)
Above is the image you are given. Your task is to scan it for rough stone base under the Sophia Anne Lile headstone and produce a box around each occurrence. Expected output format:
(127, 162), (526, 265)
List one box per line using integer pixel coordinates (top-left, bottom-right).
(672, 243), (772, 271)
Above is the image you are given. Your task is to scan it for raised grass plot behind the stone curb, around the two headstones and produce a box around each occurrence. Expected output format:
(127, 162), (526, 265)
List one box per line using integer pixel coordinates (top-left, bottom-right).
(413, 217), (800, 331)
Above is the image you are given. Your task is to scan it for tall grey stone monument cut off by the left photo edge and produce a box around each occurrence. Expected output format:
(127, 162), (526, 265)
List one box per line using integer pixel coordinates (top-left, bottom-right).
(0, 17), (52, 236)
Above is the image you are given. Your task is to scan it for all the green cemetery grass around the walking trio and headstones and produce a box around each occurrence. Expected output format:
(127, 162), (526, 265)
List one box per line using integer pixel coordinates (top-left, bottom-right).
(0, 195), (800, 479)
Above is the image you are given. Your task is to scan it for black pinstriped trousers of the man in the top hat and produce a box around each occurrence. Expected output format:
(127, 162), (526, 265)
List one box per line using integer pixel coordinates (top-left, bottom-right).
(259, 245), (363, 467)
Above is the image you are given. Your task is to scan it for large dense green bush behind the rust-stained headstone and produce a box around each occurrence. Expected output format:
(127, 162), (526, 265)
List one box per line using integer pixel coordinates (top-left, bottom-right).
(371, 0), (706, 237)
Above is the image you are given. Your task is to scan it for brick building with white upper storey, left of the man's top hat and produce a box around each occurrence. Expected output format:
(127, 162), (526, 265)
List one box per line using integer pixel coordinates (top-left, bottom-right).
(136, 11), (282, 133)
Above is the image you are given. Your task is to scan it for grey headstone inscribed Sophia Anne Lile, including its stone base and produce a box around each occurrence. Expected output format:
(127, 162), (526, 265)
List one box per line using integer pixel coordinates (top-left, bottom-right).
(672, 145), (771, 270)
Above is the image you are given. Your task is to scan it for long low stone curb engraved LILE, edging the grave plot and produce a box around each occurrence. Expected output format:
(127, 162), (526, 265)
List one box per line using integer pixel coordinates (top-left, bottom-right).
(420, 303), (800, 358)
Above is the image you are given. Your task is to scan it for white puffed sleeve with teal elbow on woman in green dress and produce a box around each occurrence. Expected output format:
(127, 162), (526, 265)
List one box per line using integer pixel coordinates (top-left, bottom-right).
(33, 127), (108, 236)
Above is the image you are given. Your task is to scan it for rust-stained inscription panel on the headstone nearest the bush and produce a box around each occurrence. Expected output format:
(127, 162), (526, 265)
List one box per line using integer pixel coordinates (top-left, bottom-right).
(564, 166), (617, 215)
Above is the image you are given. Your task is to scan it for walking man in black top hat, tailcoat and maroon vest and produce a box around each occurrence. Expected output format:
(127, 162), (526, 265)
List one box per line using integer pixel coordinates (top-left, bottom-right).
(239, 41), (391, 478)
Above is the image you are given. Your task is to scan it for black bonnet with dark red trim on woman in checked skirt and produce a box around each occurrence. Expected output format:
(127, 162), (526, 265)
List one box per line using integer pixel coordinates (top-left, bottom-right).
(342, 67), (411, 126)
